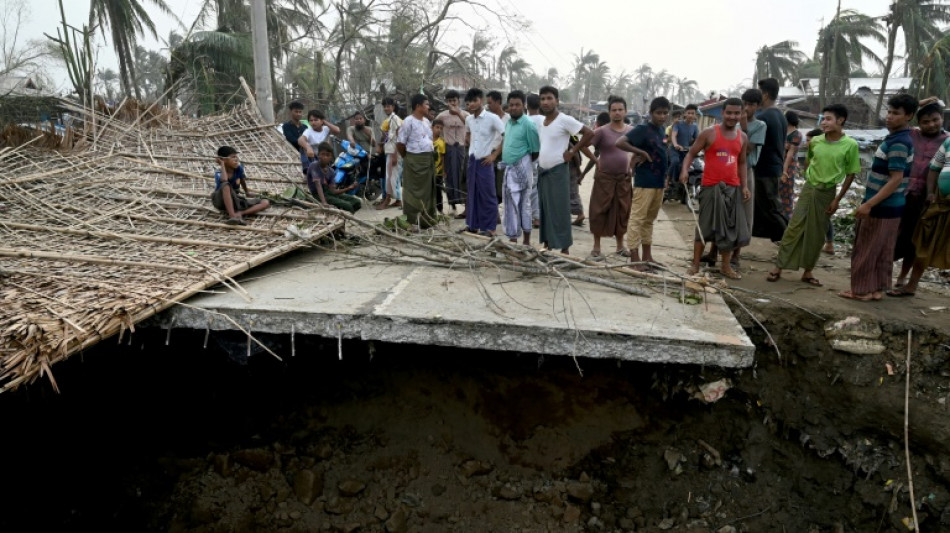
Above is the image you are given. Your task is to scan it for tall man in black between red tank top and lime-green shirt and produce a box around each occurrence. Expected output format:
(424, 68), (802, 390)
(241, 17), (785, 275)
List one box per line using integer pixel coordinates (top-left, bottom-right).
(752, 78), (788, 242)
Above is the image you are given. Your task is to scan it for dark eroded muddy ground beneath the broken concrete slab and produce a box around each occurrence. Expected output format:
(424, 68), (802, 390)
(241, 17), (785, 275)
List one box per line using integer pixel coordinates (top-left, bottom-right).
(0, 299), (950, 533)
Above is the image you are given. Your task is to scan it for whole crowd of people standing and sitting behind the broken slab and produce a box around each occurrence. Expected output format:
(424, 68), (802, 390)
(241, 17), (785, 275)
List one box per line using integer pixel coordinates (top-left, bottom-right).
(214, 78), (950, 301)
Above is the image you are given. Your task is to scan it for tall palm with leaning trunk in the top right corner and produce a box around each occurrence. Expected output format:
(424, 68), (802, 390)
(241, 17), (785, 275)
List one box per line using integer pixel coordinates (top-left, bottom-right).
(874, 0), (950, 116)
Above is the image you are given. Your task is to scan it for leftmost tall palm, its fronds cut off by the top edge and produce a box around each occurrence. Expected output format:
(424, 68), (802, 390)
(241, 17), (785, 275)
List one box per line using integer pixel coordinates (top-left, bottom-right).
(89, 0), (174, 100)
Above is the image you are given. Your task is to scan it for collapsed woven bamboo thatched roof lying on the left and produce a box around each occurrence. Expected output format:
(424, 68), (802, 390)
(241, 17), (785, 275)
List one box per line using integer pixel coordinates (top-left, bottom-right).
(0, 92), (343, 392)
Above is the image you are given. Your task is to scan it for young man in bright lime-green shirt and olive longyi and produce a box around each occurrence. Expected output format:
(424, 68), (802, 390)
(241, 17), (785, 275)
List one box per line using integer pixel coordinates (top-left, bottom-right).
(767, 104), (861, 287)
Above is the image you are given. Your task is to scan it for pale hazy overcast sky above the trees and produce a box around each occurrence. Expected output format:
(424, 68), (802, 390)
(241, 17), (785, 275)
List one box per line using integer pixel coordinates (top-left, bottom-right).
(18, 0), (901, 93)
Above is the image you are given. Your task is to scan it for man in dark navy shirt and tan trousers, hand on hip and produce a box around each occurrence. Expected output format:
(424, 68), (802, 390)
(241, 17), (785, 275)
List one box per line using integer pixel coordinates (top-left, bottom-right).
(617, 96), (670, 270)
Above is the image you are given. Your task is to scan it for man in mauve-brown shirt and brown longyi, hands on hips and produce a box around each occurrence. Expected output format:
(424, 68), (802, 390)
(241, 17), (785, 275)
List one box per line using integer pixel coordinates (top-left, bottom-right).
(588, 96), (633, 260)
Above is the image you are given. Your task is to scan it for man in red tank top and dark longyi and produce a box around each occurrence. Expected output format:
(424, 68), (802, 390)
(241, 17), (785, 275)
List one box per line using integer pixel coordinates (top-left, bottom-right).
(680, 98), (752, 279)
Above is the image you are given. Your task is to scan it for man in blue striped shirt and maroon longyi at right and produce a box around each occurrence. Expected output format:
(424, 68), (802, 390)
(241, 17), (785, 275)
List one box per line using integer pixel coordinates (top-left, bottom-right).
(838, 94), (918, 301)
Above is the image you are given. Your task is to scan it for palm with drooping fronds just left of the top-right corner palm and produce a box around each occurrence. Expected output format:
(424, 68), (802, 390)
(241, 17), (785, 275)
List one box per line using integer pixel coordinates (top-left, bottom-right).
(815, 4), (887, 106)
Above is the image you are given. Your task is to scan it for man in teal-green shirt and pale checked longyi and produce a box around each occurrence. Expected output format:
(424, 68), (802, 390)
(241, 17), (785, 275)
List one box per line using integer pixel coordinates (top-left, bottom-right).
(501, 91), (541, 244)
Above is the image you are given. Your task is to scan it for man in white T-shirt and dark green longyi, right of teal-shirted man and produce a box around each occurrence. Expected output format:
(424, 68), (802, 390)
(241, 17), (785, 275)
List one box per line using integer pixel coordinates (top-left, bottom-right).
(538, 85), (594, 254)
